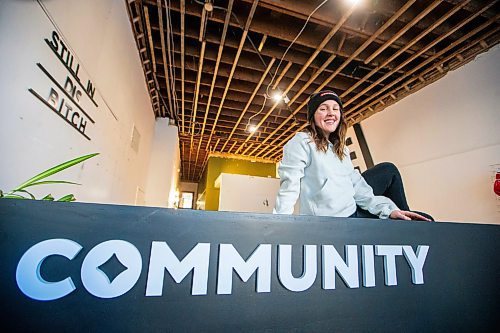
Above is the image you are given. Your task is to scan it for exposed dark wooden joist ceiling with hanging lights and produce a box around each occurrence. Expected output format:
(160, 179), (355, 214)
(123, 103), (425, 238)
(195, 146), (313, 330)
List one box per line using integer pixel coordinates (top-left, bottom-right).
(126, 0), (500, 182)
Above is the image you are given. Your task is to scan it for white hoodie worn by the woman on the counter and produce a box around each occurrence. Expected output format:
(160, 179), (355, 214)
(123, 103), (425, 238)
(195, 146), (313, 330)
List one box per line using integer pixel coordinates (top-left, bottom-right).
(273, 132), (399, 219)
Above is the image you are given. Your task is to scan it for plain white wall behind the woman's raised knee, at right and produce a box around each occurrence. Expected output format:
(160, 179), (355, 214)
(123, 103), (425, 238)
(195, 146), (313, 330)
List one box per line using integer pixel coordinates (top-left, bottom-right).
(362, 47), (500, 223)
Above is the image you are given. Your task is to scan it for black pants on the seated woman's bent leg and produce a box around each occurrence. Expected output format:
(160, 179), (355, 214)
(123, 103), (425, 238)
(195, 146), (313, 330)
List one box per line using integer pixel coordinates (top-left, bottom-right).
(353, 162), (434, 220)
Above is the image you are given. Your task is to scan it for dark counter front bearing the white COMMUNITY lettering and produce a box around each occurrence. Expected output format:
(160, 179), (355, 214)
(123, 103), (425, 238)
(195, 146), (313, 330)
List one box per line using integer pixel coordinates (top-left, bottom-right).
(0, 200), (500, 332)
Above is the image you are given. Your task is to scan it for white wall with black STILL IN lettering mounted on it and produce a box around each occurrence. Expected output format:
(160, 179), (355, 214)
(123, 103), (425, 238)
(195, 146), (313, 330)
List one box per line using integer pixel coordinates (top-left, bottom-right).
(0, 0), (158, 204)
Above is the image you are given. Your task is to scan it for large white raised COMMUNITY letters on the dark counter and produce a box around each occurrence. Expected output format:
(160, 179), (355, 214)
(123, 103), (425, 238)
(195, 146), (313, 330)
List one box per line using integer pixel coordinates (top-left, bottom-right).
(16, 239), (429, 301)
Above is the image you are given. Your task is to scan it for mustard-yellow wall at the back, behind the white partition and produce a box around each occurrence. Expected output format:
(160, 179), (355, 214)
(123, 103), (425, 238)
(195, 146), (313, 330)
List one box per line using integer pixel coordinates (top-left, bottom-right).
(200, 157), (276, 210)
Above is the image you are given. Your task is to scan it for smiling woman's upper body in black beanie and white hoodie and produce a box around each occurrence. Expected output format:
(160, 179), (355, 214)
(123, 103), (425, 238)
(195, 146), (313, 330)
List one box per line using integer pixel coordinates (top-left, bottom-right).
(274, 90), (429, 221)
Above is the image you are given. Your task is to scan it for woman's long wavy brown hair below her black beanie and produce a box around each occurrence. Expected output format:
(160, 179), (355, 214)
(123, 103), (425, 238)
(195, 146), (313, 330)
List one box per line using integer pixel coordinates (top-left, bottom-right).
(306, 112), (347, 161)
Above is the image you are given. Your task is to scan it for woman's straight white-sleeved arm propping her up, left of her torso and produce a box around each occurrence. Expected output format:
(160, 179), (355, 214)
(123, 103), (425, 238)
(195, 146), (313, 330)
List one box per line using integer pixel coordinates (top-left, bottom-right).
(273, 133), (310, 214)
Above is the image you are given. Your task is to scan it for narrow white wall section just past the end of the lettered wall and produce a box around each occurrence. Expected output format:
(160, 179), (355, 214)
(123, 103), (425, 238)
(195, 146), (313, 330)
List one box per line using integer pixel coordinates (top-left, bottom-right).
(144, 118), (180, 208)
